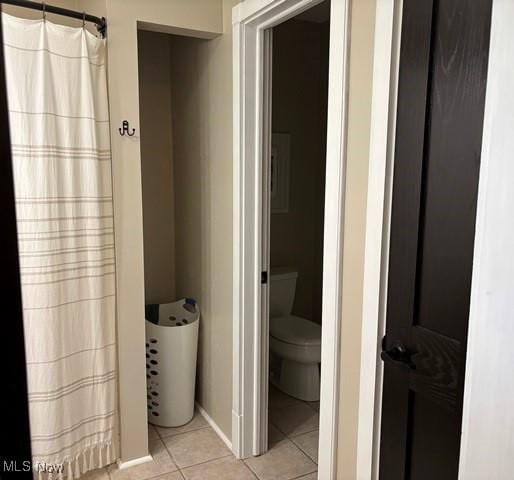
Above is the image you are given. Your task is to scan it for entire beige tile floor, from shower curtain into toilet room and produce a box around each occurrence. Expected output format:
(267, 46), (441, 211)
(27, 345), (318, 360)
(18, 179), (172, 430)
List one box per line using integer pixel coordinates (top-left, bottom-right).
(83, 386), (319, 480)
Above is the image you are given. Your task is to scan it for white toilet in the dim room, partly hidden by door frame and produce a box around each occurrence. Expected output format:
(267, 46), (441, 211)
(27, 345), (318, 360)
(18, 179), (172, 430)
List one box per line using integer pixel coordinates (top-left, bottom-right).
(269, 268), (321, 402)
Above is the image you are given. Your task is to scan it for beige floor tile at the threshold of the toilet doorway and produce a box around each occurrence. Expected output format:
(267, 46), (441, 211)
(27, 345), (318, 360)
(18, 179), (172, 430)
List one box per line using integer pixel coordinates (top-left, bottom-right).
(245, 438), (317, 480)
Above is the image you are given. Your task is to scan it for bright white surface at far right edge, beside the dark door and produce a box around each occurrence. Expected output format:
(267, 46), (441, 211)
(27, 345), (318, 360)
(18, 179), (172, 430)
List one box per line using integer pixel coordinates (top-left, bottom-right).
(459, 0), (514, 480)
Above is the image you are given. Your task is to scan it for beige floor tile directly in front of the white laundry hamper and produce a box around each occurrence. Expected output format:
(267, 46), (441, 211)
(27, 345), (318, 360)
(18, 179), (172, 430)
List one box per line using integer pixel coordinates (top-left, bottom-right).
(164, 428), (230, 468)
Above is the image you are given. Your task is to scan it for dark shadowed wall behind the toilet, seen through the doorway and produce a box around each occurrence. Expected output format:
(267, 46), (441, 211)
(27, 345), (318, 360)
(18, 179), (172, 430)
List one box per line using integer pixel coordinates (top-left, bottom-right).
(270, 20), (329, 323)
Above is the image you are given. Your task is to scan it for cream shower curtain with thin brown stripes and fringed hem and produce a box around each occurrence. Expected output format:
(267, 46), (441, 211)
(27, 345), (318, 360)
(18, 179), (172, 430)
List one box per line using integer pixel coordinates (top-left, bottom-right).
(2, 14), (118, 479)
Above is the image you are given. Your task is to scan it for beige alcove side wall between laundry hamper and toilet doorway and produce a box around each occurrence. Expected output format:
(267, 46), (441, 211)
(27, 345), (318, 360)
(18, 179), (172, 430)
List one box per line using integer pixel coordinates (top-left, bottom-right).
(171, 0), (236, 438)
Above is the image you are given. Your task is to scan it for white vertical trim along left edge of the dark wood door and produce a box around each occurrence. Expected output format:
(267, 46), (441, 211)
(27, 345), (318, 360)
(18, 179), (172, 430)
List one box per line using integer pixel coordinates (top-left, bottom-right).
(366, 0), (403, 480)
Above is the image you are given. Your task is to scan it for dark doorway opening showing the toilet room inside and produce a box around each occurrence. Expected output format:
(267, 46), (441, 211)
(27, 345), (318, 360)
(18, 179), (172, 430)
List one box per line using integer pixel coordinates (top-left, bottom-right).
(261, 0), (330, 467)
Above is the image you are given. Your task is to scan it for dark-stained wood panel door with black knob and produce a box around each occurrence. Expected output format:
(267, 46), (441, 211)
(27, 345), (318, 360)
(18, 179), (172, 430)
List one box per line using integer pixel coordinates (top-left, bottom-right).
(380, 0), (491, 480)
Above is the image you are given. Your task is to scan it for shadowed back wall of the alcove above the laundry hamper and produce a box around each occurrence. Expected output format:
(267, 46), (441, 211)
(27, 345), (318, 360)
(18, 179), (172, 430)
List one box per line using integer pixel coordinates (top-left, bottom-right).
(138, 30), (176, 303)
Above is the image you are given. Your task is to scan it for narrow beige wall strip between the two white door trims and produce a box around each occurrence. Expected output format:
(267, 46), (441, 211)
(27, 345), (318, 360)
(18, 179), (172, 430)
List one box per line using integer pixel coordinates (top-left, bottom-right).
(337, 0), (376, 480)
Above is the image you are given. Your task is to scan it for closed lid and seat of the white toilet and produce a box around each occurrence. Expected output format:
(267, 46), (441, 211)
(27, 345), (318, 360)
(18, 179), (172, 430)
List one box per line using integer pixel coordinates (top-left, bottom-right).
(270, 315), (321, 346)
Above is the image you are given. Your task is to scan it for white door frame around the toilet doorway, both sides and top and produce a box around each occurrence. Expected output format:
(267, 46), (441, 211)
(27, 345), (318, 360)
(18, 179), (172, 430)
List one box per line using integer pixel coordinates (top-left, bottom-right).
(232, 0), (348, 480)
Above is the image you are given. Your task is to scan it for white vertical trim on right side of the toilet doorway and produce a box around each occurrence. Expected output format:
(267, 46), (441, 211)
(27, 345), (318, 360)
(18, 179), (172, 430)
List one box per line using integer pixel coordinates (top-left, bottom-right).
(318, 0), (350, 480)
